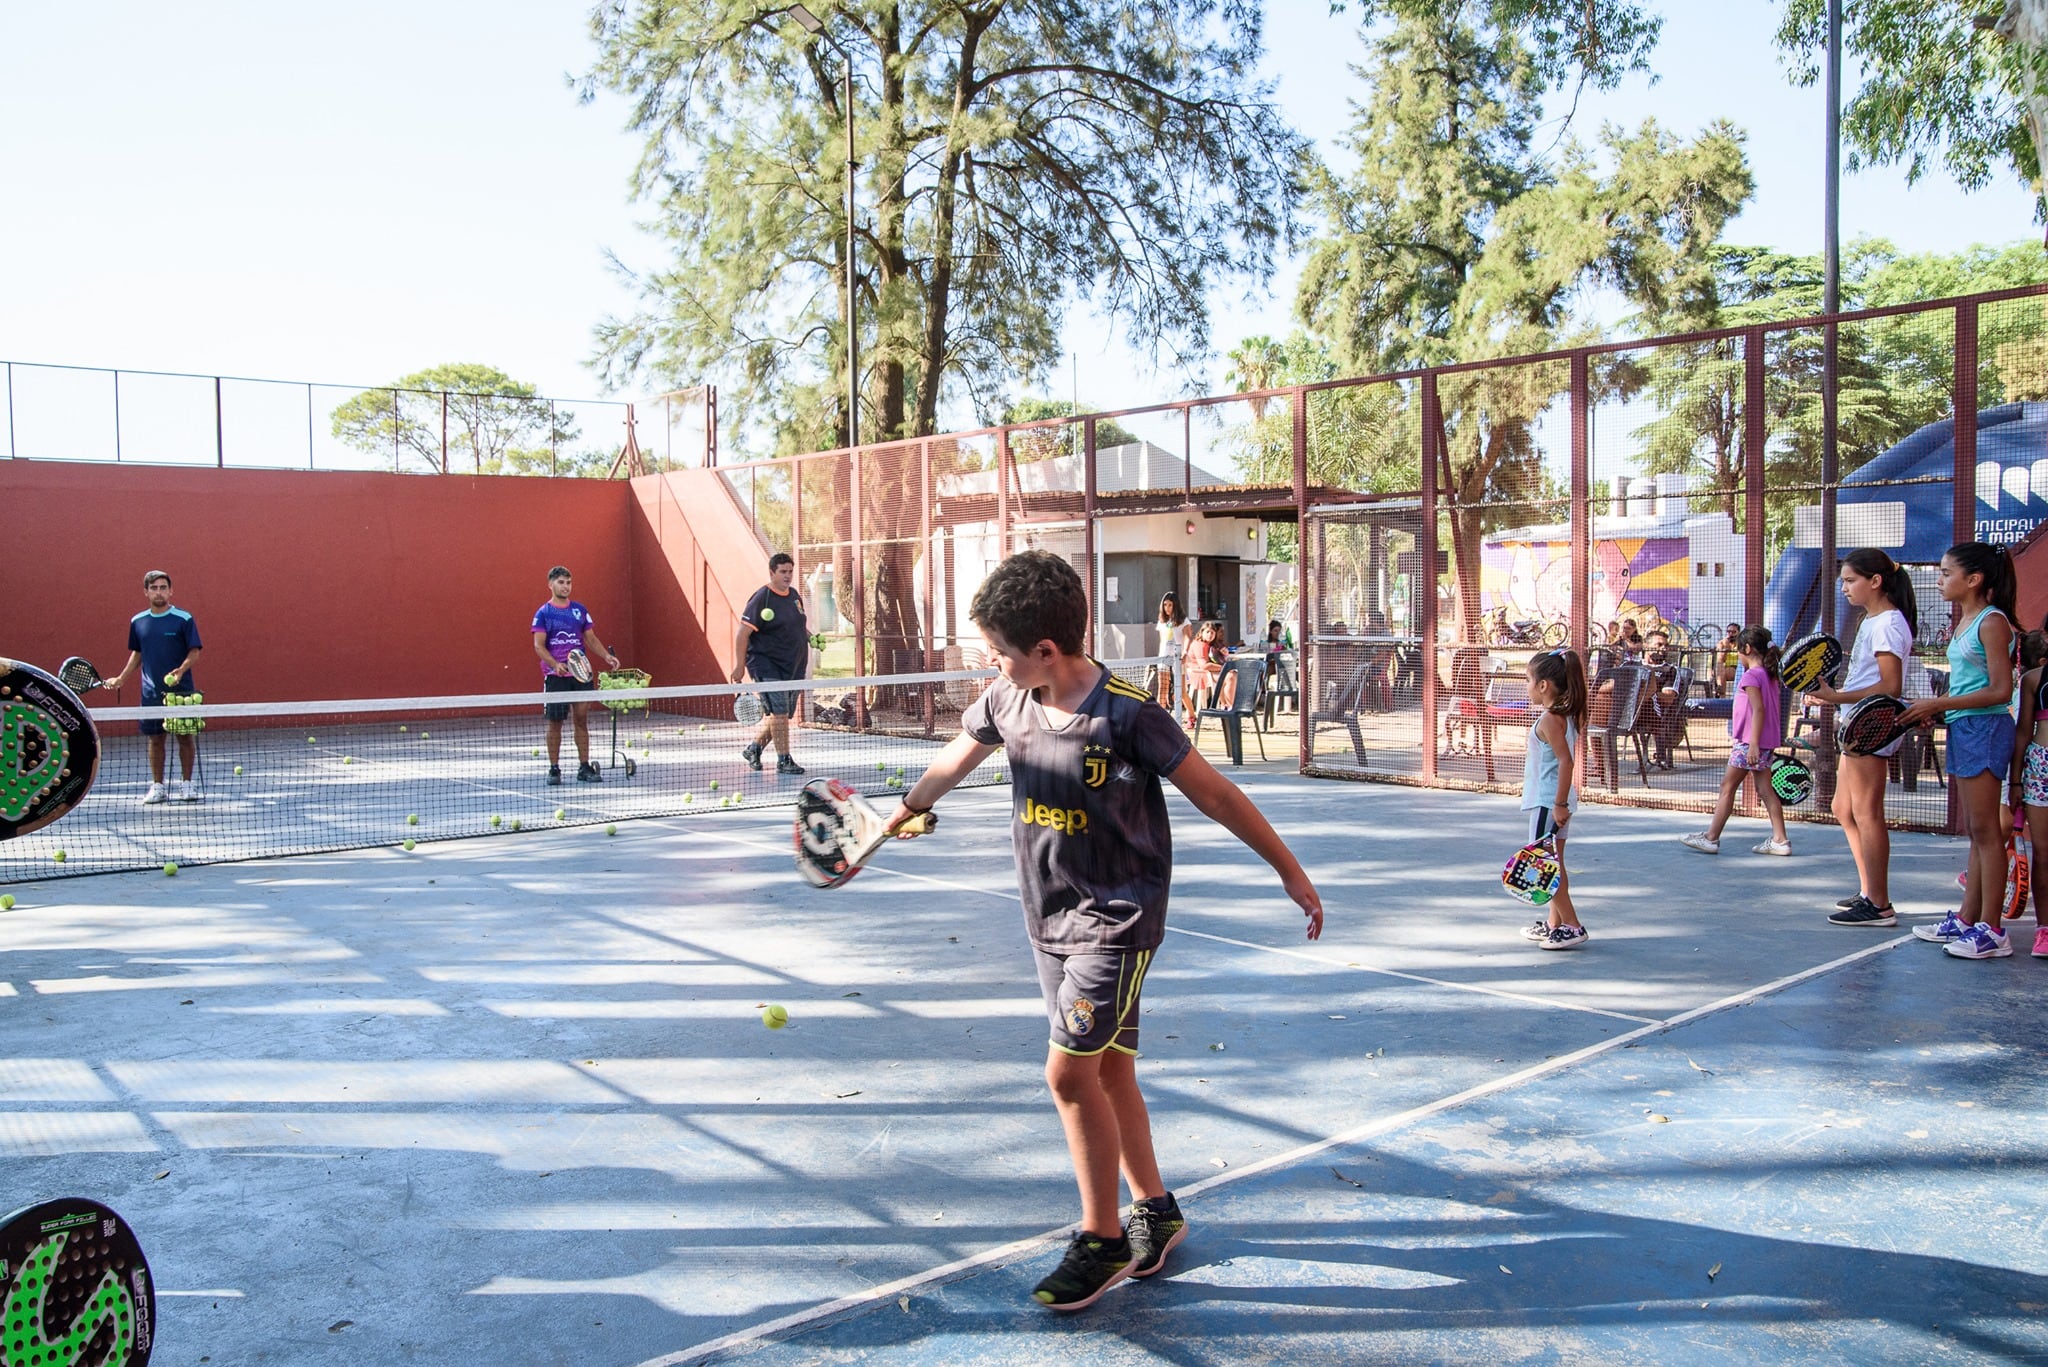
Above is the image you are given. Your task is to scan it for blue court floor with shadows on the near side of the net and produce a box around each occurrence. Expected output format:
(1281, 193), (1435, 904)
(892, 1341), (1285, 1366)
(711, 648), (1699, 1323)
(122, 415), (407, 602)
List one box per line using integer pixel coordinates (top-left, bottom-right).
(0, 771), (2048, 1367)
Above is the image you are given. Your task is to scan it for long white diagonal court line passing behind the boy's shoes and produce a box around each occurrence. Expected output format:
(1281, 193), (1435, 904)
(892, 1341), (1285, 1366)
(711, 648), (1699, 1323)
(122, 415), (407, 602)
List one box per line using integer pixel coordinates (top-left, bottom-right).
(639, 935), (1913, 1367)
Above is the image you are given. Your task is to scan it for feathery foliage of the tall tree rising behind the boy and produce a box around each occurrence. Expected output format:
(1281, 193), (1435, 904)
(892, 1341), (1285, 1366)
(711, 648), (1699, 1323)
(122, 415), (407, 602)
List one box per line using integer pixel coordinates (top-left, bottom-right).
(586, 0), (1303, 451)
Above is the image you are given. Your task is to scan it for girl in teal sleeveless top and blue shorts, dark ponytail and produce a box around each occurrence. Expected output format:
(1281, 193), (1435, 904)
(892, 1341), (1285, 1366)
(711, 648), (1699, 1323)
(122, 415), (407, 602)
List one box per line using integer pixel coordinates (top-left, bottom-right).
(1901, 541), (2019, 959)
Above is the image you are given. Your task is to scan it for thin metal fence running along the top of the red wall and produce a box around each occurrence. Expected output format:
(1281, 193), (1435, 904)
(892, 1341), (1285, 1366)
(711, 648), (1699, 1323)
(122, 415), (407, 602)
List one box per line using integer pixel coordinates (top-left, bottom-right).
(0, 361), (630, 475)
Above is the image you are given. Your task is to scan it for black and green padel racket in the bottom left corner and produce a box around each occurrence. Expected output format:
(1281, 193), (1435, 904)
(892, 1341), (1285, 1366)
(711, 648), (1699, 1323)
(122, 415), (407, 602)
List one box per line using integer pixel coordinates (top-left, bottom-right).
(0, 1197), (156, 1367)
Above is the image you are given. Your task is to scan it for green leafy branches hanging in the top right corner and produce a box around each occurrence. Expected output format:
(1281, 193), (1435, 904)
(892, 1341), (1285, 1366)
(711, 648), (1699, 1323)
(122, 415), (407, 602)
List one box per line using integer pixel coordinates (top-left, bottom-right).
(1778, 0), (2048, 202)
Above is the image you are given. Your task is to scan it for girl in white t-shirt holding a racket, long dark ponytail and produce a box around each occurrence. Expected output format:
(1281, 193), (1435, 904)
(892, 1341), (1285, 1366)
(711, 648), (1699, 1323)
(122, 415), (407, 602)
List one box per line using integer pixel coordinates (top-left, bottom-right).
(1808, 549), (1919, 928)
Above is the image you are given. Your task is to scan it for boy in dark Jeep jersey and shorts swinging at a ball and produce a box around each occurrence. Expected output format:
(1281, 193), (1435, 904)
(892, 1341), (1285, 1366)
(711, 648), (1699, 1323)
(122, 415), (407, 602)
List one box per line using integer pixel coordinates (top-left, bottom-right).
(889, 551), (1323, 1310)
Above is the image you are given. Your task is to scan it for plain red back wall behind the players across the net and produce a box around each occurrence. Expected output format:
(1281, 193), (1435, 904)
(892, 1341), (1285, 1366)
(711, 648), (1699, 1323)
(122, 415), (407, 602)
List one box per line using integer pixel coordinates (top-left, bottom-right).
(0, 461), (638, 703)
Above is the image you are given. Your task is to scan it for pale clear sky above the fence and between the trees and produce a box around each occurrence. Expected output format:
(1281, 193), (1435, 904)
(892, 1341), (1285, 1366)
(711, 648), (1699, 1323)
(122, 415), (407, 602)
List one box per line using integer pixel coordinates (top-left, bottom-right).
(0, 0), (2038, 457)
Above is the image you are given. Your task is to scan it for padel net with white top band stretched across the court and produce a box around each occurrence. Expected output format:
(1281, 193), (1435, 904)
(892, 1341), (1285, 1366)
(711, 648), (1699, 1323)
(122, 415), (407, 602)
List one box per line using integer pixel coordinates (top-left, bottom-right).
(0, 660), (1157, 883)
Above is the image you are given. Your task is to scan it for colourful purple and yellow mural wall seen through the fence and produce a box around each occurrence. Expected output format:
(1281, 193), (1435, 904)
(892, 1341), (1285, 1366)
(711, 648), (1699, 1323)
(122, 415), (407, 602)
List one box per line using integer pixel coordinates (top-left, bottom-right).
(1479, 537), (1692, 621)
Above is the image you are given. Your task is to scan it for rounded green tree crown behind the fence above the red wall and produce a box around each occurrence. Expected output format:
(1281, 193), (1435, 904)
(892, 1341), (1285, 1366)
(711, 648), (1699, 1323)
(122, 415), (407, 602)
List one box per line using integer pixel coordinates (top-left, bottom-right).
(332, 363), (585, 475)
